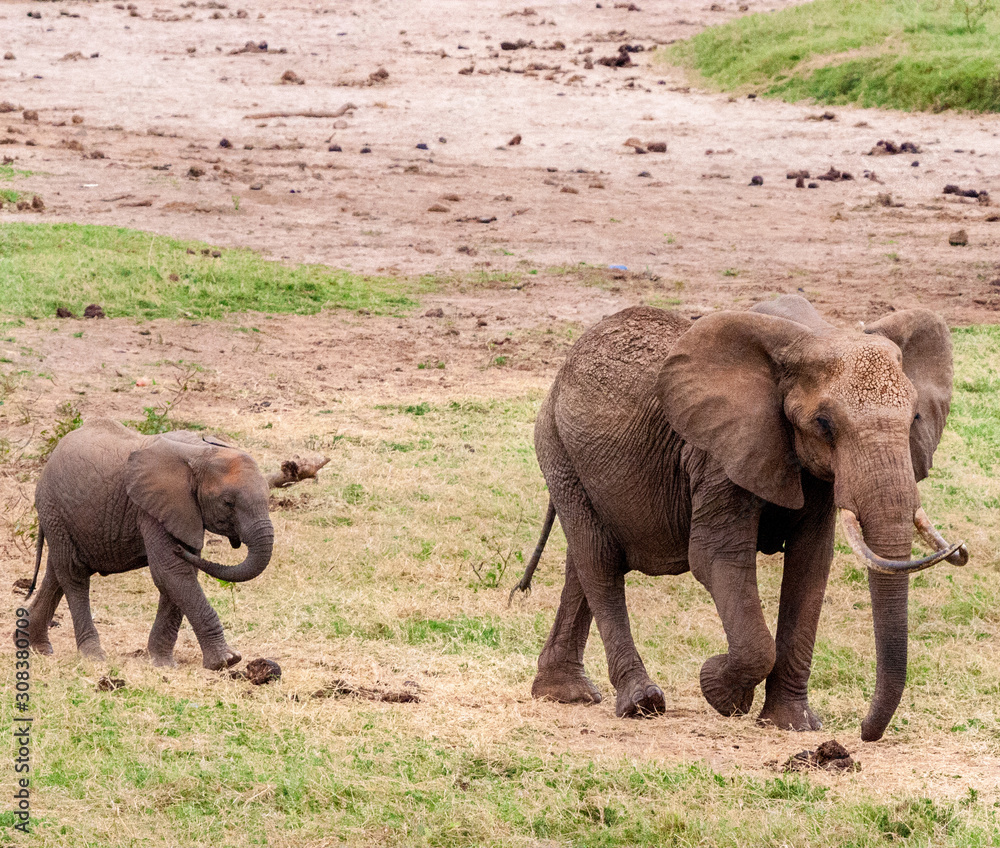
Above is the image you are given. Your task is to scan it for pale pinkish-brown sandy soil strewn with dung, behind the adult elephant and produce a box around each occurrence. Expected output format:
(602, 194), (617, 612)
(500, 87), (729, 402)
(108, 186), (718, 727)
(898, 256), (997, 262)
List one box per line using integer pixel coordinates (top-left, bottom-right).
(0, 0), (1000, 322)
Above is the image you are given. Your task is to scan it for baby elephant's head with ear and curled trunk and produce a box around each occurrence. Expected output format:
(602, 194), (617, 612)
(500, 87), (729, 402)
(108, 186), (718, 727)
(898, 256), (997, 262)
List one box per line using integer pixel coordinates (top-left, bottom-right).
(126, 434), (274, 583)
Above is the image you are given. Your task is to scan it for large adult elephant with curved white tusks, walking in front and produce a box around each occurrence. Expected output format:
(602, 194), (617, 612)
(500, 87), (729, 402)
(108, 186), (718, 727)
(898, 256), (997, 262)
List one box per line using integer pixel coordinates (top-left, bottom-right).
(511, 296), (968, 740)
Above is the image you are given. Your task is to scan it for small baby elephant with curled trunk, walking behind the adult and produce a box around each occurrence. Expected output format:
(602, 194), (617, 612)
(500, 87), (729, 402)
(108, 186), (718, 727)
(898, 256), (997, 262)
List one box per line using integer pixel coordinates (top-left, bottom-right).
(28, 419), (274, 669)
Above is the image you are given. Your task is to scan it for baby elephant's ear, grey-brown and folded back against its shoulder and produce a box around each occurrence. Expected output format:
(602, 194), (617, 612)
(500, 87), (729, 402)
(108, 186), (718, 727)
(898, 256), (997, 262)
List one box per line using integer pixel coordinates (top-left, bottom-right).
(125, 439), (205, 551)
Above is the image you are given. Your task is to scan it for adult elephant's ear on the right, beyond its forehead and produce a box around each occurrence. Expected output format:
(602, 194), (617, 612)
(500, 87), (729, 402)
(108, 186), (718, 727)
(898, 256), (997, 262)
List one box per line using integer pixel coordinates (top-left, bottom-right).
(865, 309), (952, 481)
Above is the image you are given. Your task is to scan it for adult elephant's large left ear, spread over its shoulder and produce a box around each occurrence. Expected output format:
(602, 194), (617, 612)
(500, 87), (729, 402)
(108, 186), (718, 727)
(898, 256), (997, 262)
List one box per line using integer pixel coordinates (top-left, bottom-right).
(658, 312), (812, 509)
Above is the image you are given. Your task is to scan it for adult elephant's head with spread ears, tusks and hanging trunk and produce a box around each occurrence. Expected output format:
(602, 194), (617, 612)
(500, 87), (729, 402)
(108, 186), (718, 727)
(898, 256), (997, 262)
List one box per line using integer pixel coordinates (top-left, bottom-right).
(659, 297), (967, 740)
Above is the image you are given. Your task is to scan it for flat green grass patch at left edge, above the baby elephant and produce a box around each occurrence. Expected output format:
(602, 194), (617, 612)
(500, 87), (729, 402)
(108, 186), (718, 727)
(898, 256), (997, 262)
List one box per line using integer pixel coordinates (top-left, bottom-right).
(0, 224), (416, 319)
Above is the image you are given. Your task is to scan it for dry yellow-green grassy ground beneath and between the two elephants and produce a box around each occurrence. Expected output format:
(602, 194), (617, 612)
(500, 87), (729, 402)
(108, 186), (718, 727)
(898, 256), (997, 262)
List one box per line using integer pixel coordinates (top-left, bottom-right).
(0, 320), (1000, 848)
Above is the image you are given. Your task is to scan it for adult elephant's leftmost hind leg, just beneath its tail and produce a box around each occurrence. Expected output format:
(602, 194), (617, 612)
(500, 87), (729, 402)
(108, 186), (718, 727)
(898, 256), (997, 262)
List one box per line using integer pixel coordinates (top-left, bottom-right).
(531, 557), (602, 704)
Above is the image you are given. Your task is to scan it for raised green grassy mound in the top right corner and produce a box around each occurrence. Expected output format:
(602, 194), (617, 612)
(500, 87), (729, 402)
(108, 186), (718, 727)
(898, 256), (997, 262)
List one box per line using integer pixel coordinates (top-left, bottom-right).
(665, 0), (1000, 112)
